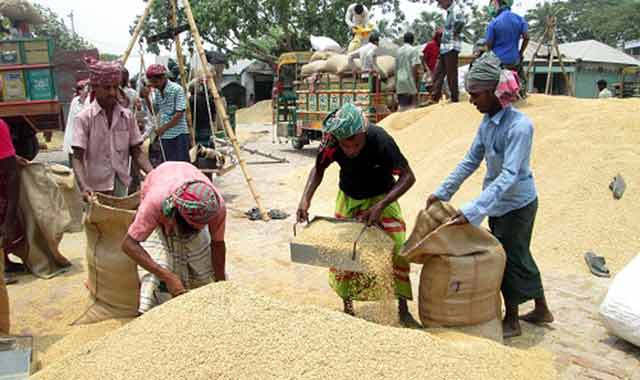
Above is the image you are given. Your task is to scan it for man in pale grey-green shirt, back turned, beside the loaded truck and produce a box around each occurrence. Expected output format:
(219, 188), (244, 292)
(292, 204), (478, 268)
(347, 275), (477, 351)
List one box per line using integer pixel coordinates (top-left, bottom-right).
(396, 32), (420, 111)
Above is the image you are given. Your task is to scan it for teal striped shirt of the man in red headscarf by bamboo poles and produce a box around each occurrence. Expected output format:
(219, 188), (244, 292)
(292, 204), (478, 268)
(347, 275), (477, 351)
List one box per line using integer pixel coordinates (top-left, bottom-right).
(153, 80), (189, 140)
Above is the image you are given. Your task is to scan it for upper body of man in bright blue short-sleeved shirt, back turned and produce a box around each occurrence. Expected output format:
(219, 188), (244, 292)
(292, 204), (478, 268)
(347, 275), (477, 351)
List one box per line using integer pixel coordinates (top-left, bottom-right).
(486, 0), (529, 66)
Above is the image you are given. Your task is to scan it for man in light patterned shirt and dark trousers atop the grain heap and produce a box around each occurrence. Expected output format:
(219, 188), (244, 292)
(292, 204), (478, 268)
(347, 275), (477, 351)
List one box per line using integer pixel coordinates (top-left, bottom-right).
(431, 0), (465, 103)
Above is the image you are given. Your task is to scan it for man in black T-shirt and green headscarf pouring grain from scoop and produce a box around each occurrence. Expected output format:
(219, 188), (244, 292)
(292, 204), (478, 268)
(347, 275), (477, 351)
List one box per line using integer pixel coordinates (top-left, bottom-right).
(297, 103), (417, 326)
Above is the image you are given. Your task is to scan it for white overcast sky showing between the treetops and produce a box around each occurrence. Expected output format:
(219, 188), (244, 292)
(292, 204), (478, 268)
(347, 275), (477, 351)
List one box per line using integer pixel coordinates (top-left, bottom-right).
(32, 0), (544, 73)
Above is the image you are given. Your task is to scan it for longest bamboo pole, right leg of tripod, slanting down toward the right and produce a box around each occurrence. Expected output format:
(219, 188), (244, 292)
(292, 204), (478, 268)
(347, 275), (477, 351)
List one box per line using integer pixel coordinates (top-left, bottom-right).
(182, 0), (269, 221)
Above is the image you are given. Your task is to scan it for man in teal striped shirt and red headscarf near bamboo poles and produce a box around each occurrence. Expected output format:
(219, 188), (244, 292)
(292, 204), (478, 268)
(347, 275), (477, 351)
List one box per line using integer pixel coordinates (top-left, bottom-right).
(146, 64), (190, 162)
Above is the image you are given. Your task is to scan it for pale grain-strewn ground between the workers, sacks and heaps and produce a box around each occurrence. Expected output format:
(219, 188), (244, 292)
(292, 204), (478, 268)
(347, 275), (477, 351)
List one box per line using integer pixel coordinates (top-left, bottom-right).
(9, 121), (640, 380)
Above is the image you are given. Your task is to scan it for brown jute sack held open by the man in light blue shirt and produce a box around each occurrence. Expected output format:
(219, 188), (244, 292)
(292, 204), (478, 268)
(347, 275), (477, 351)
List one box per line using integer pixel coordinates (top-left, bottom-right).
(402, 202), (506, 327)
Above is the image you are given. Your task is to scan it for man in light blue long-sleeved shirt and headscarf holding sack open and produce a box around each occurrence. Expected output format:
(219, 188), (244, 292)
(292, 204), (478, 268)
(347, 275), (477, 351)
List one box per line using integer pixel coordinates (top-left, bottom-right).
(427, 52), (553, 338)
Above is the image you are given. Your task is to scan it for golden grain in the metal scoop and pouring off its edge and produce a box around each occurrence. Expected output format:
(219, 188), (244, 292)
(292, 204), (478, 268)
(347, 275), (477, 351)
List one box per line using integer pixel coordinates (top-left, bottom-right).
(294, 220), (395, 302)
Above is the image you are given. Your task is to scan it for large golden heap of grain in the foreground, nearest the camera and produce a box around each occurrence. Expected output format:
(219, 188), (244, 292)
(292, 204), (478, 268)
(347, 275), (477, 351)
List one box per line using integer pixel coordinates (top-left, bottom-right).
(33, 282), (555, 380)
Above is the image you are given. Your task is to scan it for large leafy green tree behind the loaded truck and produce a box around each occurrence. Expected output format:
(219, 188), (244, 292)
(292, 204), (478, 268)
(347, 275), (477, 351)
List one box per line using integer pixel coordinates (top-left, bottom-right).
(136, 0), (404, 64)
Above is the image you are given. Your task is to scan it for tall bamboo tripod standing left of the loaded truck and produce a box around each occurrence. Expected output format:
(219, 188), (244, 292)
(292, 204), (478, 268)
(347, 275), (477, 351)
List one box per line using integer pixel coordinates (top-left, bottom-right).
(123, 0), (269, 221)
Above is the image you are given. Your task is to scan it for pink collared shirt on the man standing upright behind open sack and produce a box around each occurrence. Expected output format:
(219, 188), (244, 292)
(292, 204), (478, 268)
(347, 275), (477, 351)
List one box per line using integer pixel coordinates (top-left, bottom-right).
(71, 101), (142, 192)
